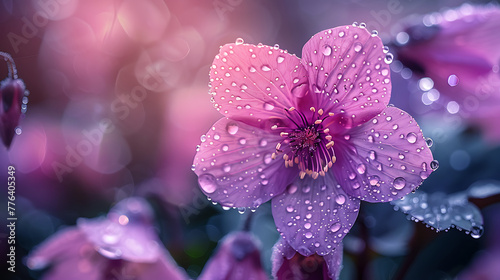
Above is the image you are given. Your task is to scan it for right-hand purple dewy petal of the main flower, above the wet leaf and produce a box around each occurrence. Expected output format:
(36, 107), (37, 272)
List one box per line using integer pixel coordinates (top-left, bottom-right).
(333, 107), (437, 202)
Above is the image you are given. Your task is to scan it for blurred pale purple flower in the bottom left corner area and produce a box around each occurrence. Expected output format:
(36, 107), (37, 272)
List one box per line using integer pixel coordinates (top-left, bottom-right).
(28, 198), (188, 280)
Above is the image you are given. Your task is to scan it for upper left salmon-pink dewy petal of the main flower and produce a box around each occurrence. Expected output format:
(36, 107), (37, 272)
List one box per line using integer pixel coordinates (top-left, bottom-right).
(210, 44), (308, 129)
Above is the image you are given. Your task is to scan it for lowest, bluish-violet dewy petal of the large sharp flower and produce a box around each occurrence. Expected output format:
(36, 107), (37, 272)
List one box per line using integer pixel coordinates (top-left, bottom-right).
(272, 172), (359, 256)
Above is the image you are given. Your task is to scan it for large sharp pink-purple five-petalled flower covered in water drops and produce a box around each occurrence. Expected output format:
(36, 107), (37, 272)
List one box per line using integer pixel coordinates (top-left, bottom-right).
(193, 25), (433, 256)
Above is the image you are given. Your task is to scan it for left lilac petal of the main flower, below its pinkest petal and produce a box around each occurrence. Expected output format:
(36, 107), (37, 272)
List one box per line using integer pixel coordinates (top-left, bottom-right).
(193, 118), (298, 208)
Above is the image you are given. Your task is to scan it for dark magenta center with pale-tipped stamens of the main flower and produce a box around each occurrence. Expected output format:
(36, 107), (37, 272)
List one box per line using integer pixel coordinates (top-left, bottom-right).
(272, 107), (336, 179)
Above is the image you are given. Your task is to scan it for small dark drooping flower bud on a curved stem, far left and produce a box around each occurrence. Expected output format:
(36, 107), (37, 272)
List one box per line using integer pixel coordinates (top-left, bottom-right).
(0, 52), (26, 148)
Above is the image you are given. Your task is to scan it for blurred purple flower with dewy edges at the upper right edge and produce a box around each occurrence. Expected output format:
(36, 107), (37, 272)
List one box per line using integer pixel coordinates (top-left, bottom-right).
(394, 4), (500, 141)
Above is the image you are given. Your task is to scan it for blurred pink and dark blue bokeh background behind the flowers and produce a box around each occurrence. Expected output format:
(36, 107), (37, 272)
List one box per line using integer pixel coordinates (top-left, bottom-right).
(0, 0), (500, 279)
